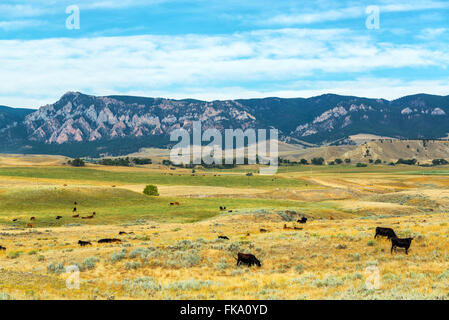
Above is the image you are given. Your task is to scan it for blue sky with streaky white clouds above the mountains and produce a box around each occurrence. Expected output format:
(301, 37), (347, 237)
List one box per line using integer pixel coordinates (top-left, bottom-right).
(0, 0), (449, 108)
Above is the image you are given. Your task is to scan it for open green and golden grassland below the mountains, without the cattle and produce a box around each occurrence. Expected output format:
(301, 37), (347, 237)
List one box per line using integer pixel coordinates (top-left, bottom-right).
(0, 157), (449, 299)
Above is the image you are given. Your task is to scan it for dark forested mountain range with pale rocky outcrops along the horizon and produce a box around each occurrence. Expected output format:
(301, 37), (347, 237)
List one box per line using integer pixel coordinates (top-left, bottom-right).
(0, 92), (449, 157)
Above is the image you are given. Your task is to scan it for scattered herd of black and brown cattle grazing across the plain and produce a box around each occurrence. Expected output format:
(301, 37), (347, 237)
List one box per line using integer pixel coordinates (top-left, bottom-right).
(0, 201), (413, 267)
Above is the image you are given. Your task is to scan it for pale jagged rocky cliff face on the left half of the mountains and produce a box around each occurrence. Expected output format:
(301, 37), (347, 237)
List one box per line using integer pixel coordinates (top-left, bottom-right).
(24, 92), (255, 144)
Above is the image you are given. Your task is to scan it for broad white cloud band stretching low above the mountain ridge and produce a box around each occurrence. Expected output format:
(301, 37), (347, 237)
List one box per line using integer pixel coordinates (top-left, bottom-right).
(0, 29), (449, 107)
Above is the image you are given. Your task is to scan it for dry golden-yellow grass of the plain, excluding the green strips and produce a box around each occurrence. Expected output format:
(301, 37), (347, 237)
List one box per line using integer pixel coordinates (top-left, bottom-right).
(0, 160), (449, 299)
